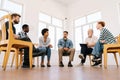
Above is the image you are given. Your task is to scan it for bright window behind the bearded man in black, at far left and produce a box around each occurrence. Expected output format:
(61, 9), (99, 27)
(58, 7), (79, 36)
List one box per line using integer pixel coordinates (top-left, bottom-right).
(0, 0), (23, 33)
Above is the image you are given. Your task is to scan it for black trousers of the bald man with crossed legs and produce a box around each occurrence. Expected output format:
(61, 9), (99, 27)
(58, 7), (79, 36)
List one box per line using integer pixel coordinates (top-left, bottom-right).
(81, 47), (93, 63)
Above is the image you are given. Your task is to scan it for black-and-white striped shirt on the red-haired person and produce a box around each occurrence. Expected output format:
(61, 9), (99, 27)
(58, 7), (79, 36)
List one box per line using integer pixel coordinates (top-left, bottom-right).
(99, 28), (116, 44)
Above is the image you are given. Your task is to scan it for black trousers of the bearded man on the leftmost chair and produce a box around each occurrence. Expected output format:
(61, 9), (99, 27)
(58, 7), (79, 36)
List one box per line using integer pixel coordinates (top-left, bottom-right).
(20, 37), (35, 65)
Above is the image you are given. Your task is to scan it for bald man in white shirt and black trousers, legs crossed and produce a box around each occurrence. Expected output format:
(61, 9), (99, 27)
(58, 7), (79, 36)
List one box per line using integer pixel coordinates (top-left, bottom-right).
(79, 29), (97, 65)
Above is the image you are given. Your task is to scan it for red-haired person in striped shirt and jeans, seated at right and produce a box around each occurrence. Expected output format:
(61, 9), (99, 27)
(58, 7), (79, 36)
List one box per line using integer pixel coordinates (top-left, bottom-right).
(92, 21), (116, 66)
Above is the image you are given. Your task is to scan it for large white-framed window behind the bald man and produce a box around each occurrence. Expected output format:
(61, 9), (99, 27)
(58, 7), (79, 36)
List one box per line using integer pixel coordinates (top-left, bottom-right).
(74, 12), (102, 50)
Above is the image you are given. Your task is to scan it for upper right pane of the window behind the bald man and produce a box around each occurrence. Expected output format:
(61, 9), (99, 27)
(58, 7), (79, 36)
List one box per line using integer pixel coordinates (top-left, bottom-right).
(87, 12), (102, 23)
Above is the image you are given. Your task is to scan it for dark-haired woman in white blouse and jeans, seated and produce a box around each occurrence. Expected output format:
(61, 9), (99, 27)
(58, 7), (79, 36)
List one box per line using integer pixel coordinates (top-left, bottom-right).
(39, 28), (52, 67)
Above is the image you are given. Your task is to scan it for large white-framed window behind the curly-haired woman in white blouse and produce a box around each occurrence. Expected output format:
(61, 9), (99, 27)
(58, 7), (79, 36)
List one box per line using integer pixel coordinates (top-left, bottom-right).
(38, 13), (63, 50)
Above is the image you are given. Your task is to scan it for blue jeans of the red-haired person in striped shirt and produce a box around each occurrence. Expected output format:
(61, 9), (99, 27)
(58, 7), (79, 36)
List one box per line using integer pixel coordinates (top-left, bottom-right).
(92, 40), (103, 57)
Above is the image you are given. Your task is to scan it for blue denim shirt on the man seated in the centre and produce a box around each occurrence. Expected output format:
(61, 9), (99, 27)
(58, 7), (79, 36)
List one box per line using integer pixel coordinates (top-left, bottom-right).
(58, 38), (73, 48)
